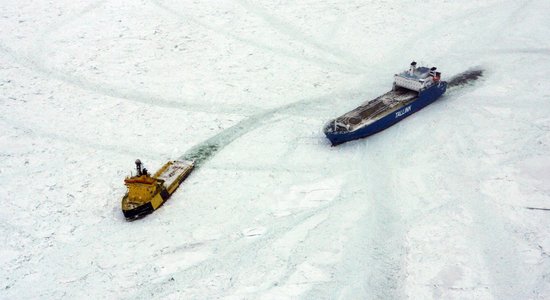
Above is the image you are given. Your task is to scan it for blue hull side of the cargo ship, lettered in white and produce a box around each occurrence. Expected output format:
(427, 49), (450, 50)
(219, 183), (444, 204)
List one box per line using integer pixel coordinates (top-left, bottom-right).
(325, 81), (447, 146)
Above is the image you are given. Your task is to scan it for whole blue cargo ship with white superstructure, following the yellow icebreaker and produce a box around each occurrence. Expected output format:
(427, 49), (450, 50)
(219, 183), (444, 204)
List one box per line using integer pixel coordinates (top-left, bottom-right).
(324, 62), (447, 146)
